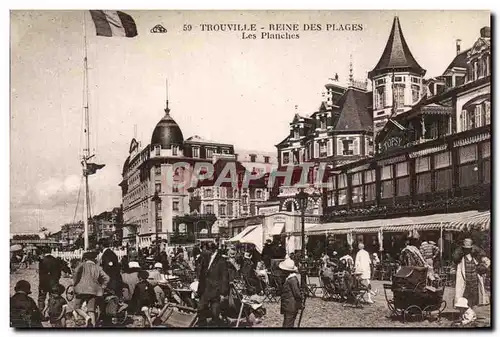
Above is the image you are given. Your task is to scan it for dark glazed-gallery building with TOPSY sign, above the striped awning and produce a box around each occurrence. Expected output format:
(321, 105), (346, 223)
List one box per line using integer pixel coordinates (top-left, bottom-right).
(323, 21), (491, 222)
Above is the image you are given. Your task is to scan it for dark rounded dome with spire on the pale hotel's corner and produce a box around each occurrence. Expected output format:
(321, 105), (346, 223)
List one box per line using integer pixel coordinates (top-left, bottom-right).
(151, 100), (184, 156)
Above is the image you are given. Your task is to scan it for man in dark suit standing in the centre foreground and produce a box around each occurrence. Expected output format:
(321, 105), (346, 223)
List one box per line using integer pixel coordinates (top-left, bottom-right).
(198, 242), (229, 326)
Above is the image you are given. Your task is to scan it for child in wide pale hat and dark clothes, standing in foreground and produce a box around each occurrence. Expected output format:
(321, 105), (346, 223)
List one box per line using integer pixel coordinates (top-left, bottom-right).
(278, 259), (302, 328)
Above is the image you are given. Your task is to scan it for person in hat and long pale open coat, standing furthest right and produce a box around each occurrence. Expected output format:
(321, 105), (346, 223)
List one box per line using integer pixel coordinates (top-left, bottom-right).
(453, 238), (490, 308)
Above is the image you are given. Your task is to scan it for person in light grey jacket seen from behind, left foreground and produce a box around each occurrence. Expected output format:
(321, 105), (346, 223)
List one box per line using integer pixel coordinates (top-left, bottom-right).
(73, 252), (109, 327)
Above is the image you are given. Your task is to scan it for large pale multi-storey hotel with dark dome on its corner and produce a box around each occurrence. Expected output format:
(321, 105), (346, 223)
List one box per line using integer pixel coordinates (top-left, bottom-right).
(120, 104), (273, 246)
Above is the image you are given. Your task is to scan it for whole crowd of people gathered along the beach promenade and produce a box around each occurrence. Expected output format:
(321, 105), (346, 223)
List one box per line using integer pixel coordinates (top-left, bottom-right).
(11, 236), (490, 327)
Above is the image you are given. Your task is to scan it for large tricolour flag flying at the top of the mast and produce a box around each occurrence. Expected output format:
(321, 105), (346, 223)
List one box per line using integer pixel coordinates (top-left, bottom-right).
(90, 10), (137, 37)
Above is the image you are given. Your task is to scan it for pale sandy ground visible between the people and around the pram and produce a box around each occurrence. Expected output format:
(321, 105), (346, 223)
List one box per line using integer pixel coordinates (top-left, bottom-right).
(10, 265), (491, 328)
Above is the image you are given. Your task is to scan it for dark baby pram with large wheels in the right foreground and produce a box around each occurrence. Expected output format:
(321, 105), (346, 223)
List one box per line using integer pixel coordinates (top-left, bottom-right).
(384, 267), (446, 321)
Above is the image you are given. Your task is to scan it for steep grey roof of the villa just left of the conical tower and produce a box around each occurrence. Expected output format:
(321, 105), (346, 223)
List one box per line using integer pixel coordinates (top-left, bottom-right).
(334, 88), (373, 131)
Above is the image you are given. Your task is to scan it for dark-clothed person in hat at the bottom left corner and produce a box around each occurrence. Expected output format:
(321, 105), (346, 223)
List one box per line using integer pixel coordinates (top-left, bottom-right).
(10, 280), (43, 328)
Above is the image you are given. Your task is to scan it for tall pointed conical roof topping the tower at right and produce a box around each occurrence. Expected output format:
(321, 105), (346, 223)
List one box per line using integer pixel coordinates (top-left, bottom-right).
(368, 16), (425, 78)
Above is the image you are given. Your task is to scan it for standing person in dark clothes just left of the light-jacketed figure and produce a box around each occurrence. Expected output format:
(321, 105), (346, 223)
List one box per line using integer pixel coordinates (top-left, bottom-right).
(38, 254), (71, 312)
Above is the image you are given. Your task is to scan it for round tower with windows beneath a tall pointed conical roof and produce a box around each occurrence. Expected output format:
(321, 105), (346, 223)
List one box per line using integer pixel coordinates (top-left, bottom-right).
(368, 16), (426, 133)
